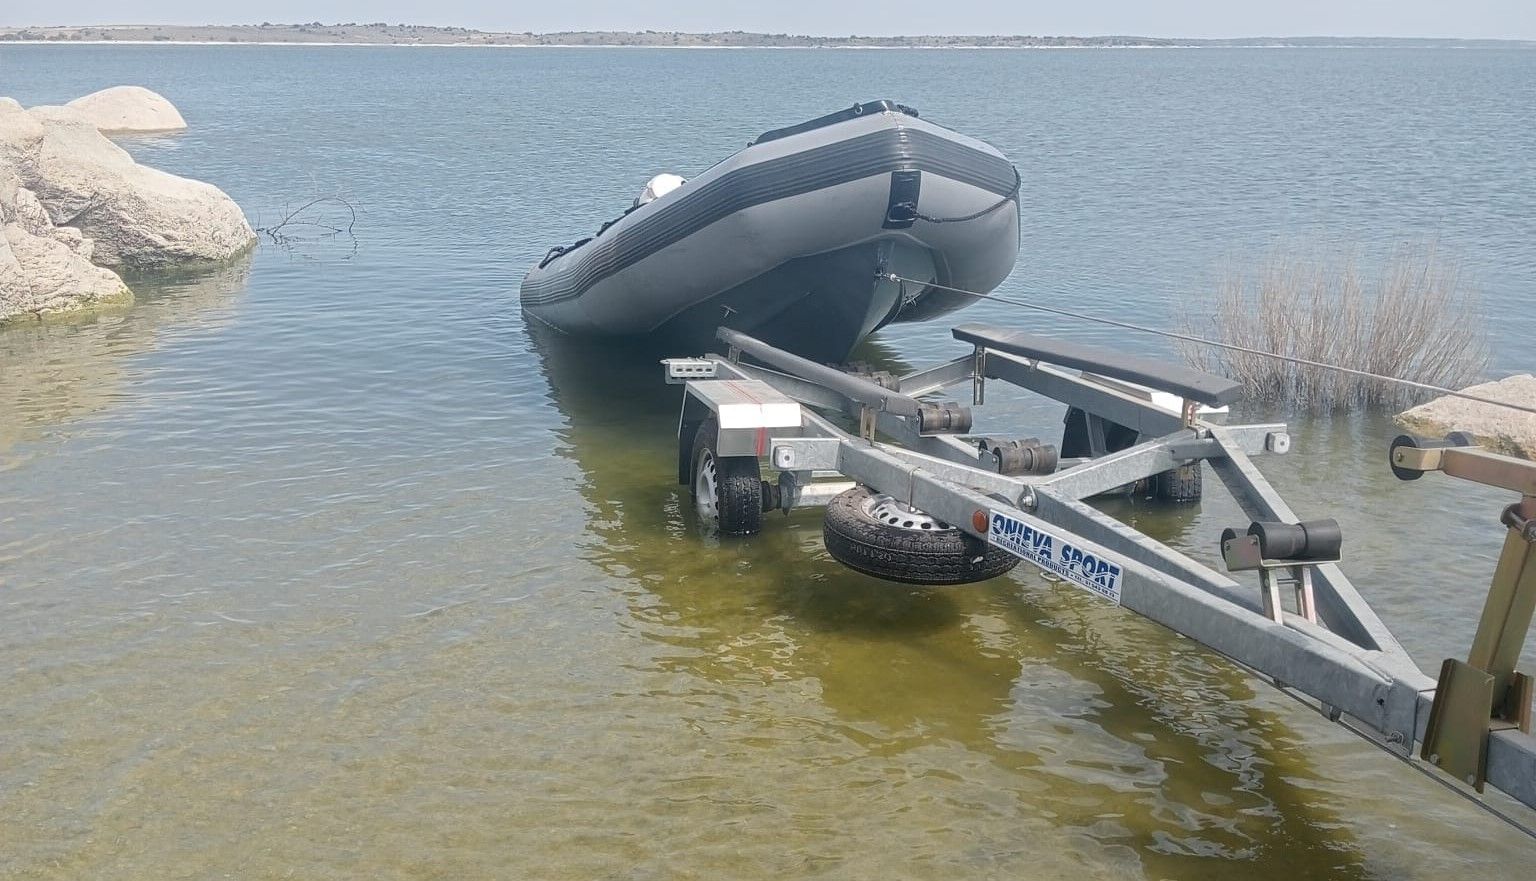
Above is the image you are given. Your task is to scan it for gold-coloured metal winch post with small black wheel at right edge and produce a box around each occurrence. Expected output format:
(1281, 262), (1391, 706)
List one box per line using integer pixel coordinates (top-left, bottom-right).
(1389, 431), (1536, 792)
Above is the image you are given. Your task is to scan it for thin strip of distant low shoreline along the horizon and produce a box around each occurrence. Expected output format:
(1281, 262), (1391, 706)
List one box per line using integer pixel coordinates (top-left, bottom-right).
(0, 21), (1536, 49)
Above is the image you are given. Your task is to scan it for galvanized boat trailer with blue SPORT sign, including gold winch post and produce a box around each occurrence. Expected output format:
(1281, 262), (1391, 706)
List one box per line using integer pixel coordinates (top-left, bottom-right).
(664, 324), (1536, 809)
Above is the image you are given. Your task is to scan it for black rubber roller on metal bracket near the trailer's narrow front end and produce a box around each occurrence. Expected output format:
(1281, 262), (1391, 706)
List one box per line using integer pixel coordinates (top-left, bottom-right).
(1221, 517), (1344, 625)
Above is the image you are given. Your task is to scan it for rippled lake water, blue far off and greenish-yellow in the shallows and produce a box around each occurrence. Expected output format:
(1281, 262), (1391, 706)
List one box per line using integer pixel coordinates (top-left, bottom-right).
(0, 46), (1536, 881)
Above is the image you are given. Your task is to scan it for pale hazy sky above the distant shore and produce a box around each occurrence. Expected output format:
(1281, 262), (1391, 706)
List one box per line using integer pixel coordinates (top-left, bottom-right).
(9, 0), (1536, 40)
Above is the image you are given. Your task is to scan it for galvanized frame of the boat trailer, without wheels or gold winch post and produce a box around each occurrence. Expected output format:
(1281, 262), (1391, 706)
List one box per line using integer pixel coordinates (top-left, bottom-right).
(665, 324), (1536, 809)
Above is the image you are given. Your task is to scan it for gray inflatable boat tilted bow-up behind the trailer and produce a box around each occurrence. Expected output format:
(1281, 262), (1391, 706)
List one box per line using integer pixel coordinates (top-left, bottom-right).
(522, 101), (1020, 361)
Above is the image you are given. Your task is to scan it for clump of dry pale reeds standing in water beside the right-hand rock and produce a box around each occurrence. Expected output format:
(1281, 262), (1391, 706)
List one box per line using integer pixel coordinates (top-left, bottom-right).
(1180, 246), (1488, 410)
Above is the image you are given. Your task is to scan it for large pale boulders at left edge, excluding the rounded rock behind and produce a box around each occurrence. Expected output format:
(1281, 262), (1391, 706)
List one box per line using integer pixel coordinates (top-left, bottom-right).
(0, 91), (257, 321)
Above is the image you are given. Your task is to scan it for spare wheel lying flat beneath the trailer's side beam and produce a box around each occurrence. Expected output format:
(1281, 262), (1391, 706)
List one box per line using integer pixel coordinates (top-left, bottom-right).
(822, 487), (1018, 585)
